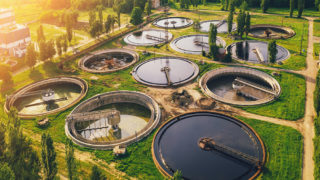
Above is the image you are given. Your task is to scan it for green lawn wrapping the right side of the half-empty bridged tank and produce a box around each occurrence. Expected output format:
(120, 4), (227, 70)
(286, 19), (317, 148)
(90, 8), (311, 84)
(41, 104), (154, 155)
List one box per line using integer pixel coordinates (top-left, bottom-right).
(241, 72), (306, 120)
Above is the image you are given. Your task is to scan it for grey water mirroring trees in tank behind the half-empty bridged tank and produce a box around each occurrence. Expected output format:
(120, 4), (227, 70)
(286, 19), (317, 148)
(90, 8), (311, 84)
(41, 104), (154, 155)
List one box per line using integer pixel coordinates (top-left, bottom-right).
(231, 41), (288, 63)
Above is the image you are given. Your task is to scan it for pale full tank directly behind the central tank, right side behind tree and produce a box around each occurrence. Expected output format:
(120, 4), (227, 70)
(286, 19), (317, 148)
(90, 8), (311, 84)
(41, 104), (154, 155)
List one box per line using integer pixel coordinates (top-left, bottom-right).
(170, 34), (226, 54)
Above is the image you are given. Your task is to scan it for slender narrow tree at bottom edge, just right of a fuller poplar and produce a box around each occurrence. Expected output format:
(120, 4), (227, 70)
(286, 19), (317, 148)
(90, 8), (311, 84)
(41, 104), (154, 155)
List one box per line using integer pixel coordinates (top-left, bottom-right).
(65, 139), (77, 180)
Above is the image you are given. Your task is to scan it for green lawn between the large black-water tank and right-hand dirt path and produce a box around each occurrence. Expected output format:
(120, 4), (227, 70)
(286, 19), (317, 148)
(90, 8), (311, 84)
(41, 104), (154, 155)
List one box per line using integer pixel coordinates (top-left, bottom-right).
(240, 118), (303, 180)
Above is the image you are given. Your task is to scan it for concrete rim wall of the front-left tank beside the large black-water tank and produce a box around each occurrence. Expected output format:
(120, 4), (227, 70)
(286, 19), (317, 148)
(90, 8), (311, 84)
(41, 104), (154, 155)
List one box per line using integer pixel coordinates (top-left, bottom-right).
(65, 91), (161, 150)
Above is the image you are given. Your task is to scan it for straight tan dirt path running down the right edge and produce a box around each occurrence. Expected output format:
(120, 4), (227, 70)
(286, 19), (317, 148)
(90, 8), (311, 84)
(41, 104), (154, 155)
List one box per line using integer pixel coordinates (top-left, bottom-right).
(302, 18), (318, 180)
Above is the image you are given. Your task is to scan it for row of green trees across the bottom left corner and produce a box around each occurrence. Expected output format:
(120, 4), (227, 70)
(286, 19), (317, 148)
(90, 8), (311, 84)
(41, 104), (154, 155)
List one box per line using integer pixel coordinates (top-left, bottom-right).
(0, 109), (106, 180)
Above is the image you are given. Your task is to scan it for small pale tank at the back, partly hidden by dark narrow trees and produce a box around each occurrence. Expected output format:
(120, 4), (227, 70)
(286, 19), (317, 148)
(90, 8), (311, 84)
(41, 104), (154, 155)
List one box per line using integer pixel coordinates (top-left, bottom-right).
(200, 20), (237, 33)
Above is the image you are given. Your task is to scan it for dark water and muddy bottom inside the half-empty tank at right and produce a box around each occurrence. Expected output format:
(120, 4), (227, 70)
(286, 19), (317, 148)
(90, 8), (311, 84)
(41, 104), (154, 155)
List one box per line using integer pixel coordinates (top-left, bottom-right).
(207, 75), (272, 101)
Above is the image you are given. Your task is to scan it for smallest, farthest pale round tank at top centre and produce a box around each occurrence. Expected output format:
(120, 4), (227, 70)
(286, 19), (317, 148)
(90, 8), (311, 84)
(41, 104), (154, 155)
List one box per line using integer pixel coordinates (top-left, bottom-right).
(153, 17), (193, 29)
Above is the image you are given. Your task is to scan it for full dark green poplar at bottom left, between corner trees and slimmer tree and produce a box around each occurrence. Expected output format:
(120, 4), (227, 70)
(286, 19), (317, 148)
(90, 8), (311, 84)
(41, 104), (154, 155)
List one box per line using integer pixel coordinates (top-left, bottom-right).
(41, 133), (58, 180)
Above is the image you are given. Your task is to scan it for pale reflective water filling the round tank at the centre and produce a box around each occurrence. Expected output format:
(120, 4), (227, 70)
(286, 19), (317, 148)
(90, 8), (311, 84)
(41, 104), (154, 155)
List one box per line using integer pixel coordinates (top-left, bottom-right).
(136, 57), (195, 85)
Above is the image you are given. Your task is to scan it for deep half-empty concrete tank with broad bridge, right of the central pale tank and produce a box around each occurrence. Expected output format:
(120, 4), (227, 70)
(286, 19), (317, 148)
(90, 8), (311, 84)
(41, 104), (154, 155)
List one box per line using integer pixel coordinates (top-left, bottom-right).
(199, 67), (281, 106)
